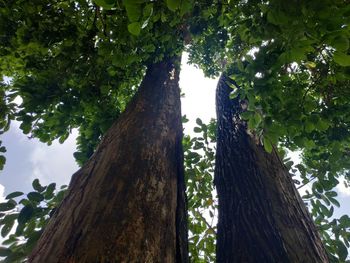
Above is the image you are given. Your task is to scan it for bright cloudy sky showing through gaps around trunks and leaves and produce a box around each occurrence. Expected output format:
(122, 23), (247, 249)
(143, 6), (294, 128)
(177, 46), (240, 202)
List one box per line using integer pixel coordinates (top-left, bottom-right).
(0, 56), (350, 216)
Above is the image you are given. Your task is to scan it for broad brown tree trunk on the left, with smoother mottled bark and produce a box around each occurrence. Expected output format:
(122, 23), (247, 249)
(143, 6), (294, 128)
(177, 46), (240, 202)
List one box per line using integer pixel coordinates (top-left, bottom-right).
(29, 58), (188, 263)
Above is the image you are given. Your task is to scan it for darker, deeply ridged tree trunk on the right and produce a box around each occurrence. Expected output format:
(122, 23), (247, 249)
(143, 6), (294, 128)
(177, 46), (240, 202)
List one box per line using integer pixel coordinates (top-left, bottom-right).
(215, 76), (328, 263)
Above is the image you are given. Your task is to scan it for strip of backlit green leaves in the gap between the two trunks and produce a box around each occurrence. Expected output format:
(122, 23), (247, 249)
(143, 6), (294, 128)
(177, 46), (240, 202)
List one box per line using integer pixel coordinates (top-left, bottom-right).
(183, 118), (217, 262)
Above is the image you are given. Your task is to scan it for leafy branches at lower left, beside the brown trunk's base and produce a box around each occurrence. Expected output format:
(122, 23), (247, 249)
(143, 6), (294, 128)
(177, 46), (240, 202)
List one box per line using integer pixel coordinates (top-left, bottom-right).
(0, 179), (67, 263)
